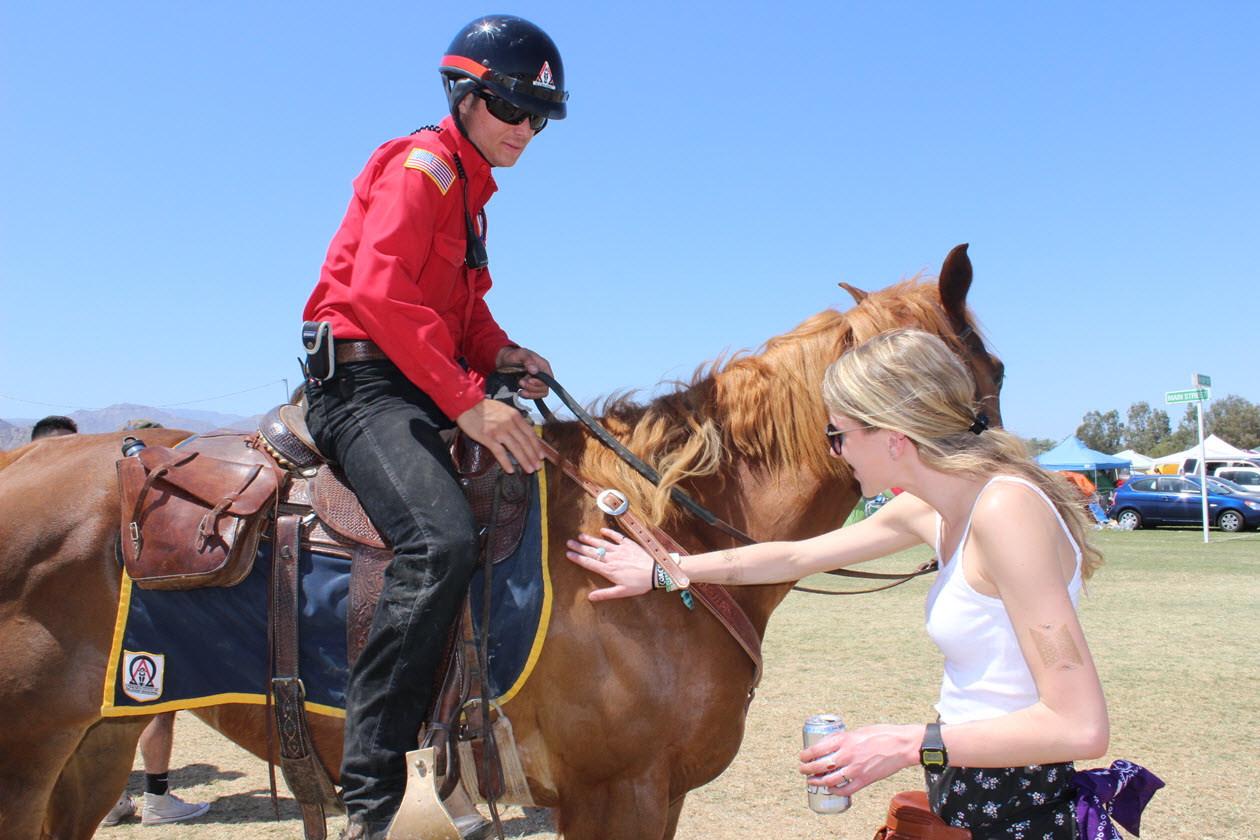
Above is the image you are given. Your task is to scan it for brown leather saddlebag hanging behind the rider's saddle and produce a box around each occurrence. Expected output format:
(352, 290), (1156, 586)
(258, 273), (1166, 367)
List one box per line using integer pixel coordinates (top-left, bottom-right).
(118, 434), (280, 589)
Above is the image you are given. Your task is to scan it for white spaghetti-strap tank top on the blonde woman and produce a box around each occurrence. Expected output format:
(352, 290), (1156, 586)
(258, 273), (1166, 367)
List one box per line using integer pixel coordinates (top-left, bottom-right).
(927, 476), (1081, 723)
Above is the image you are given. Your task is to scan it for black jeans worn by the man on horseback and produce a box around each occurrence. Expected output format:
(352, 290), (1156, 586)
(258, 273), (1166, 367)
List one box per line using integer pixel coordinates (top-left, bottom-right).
(306, 361), (478, 826)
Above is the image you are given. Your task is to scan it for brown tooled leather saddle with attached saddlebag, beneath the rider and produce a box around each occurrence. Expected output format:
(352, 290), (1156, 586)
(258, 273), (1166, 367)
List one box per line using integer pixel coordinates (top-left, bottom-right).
(118, 404), (529, 840)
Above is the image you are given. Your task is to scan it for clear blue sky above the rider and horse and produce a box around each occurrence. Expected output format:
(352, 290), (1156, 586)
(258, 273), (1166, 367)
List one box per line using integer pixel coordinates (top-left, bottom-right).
(0, 0), (1260, 440)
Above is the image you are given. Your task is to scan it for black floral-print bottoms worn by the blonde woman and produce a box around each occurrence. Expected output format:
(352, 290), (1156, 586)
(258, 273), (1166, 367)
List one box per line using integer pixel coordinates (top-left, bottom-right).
(925, 763), (1076, 840)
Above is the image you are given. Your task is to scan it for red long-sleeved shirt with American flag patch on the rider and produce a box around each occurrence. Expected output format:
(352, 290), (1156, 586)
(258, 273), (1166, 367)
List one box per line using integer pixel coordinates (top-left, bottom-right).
(302, 117), (510, 419)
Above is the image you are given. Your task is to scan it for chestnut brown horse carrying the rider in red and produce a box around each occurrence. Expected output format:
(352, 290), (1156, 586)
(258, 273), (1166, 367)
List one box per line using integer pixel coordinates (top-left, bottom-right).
(0, 246), (1002, 840)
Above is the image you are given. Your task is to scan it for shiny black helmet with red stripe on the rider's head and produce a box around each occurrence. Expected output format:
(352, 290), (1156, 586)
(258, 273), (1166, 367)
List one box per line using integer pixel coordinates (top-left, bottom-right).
(438, 15), (568, 120)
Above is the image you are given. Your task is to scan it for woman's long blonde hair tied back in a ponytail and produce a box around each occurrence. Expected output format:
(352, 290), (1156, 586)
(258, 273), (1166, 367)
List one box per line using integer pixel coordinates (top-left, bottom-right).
(823, 330), (1103, 578)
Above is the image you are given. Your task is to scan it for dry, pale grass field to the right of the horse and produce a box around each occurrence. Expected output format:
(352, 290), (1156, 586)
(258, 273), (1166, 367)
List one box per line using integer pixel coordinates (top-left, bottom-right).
(679, 529), (1260, 840)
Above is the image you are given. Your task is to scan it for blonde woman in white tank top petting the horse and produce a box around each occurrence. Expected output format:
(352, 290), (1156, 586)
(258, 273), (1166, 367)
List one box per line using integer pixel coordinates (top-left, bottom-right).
(568, 330), (1109, 840)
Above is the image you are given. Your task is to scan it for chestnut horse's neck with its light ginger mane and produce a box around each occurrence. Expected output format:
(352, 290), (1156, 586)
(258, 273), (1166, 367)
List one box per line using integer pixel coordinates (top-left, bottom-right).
(548, 311), (859, 631)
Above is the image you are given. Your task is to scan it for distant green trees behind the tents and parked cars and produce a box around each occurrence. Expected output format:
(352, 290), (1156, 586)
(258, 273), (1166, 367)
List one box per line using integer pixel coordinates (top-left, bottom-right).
(1026, 394), (1260, 458)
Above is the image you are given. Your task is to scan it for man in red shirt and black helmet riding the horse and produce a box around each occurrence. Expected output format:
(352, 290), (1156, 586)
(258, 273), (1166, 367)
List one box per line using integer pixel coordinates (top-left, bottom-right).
(304, 15), (568, 839)
